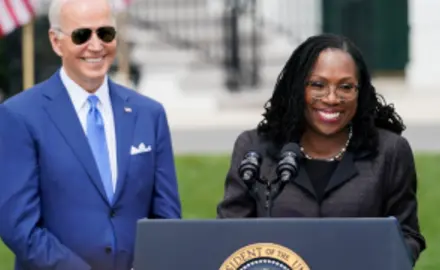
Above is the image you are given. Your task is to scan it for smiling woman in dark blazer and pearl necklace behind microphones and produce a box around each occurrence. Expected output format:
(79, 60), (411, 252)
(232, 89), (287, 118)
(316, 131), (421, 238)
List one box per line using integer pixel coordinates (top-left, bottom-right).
(218, 34), (425, 262)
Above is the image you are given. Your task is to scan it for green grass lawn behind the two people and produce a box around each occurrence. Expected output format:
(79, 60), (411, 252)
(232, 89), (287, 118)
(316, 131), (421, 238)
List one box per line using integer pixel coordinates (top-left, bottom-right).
(0, 155), (440, 270)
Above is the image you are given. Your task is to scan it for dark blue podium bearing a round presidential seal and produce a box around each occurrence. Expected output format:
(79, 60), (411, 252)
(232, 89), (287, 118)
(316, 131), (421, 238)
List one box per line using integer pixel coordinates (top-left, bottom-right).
(134, 218), (412, 270)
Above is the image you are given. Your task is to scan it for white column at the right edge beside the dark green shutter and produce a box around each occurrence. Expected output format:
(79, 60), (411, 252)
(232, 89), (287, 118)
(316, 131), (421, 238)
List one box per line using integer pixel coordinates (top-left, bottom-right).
(406, 0), (440, 93)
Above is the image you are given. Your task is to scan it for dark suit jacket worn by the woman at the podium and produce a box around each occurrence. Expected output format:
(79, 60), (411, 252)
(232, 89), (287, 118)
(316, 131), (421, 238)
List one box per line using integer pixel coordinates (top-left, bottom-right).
(217, 127), (425, 261)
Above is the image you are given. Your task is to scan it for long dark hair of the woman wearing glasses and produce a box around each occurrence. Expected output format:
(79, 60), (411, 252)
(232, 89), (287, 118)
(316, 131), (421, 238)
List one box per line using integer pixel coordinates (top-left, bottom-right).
(257, 34), (405, 156)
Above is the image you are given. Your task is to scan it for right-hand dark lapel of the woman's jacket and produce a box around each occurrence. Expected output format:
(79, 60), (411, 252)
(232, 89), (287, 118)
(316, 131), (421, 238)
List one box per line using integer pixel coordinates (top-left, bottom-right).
(325, 152), (358, 194)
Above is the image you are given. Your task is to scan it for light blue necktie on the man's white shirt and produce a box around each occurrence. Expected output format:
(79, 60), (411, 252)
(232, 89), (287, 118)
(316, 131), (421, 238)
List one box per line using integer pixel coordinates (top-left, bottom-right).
(87, 95), (113, 203)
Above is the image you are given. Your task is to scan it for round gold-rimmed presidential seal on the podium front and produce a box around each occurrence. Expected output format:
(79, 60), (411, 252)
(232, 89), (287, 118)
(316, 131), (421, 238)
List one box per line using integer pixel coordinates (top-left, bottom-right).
(219, 243), (310, 270)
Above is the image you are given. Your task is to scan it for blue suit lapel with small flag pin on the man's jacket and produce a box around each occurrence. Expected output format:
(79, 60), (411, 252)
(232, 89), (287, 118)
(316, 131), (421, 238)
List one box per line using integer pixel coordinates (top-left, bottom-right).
(109, 80), (137, 203)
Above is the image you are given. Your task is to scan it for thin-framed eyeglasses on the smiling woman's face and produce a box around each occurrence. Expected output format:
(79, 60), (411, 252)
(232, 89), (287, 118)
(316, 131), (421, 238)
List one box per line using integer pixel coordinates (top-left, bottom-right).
(306, 81), (359, 101)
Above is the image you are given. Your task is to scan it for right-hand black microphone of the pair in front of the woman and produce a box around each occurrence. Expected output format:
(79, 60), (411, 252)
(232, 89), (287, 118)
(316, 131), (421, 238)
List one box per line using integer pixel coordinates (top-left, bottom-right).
(276, 143), (301, 185)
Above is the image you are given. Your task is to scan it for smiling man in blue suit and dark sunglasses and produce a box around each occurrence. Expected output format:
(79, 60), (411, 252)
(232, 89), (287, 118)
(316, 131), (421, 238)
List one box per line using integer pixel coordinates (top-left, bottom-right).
(0, 0), (181, 270)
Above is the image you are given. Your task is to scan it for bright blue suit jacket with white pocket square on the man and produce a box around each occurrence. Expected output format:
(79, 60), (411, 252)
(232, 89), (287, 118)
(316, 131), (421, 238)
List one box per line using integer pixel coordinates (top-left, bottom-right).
(0, 73), (181, 270)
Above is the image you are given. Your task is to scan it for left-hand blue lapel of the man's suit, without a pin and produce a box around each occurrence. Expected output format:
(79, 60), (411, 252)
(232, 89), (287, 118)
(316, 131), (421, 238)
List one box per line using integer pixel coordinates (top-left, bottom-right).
(44, 72), (108, 204)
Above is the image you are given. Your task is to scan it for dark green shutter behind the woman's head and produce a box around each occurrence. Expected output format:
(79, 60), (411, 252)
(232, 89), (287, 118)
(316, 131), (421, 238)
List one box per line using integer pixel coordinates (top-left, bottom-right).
(322, 0), (409, 73)
